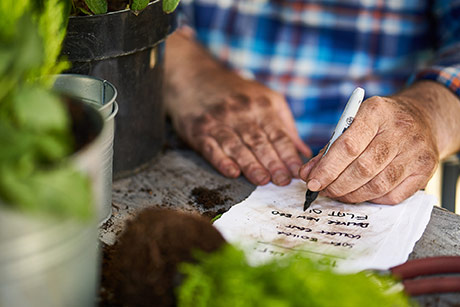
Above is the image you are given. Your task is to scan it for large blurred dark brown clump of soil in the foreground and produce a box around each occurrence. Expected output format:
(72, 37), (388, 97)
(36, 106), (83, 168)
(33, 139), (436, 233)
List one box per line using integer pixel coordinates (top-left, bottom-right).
(99, 208), (225, 307)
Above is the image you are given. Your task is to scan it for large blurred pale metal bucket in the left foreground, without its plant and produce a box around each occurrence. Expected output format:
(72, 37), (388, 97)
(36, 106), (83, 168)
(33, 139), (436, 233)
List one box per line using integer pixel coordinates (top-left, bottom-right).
(0, 100), (104, 307)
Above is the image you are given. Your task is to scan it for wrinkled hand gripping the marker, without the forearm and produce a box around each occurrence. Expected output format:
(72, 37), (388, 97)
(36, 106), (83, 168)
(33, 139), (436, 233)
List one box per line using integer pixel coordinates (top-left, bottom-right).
(300, 96), (439, 204)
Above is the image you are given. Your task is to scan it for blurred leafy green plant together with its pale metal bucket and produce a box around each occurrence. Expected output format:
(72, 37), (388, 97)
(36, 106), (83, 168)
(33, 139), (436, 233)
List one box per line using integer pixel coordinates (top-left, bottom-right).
(0, 0), (104, 307)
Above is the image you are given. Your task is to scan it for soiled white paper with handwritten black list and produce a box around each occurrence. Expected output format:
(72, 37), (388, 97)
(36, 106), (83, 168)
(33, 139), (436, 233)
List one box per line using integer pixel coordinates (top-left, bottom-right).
(214, 180), (437, 272)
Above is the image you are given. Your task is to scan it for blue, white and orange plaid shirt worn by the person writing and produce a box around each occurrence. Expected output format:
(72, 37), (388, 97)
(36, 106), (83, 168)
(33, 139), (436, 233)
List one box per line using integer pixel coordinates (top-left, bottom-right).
(180, 0), (460, 151)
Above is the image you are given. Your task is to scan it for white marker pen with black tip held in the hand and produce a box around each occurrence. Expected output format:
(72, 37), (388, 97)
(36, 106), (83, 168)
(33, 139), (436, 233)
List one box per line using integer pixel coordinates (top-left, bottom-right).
(303, 87), (364, 211)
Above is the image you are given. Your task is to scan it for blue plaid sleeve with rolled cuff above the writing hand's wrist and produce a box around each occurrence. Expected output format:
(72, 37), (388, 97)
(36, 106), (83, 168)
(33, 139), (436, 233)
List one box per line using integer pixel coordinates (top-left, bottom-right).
(416, 0), (460, 97)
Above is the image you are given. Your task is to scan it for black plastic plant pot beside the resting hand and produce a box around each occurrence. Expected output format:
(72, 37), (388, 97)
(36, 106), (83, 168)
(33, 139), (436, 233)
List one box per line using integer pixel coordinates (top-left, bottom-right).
(62, 0), (174, 178)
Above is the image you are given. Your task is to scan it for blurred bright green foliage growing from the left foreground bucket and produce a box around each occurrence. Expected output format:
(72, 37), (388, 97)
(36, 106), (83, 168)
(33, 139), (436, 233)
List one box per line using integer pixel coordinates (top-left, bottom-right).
(0, 0), (93, 218)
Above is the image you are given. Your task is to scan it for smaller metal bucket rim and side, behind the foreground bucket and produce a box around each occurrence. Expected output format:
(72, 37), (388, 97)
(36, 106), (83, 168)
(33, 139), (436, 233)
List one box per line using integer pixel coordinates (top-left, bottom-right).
(54, 74), (118, 224)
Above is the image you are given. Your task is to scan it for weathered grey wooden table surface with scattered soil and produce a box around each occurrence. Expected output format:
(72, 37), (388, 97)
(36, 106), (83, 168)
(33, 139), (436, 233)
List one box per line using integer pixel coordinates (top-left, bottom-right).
(100, 146), (460, 306)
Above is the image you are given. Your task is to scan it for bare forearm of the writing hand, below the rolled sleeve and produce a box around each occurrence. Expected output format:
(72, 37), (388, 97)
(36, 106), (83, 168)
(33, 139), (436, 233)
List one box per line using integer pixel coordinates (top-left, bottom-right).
(394, 81), (460, 159)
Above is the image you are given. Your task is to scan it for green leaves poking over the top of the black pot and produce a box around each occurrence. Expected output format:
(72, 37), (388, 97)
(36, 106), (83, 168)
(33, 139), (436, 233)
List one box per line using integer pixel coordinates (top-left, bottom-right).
(72, 0), (180, 15)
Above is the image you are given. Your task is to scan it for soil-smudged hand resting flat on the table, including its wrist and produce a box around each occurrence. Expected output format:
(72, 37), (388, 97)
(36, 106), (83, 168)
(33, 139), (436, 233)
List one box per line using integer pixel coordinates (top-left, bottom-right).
(166, 30), (311, 185)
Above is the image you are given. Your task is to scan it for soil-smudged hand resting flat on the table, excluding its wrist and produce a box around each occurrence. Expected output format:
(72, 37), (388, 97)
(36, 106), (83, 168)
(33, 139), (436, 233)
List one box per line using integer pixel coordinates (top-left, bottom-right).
(173, 75), (311, 185)
